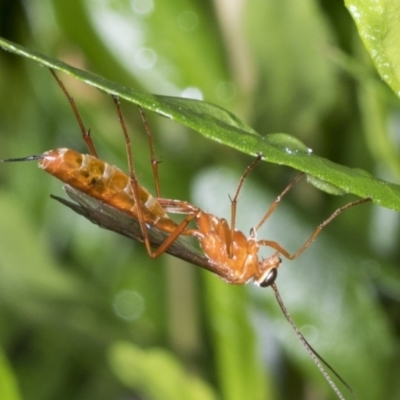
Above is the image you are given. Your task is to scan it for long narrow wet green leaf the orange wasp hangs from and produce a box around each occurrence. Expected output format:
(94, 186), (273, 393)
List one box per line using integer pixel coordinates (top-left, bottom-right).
(0, 38), (400, 211)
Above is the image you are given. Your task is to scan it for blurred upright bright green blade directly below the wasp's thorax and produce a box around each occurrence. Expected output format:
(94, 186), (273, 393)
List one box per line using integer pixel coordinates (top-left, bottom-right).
(203, 273), (273, 400)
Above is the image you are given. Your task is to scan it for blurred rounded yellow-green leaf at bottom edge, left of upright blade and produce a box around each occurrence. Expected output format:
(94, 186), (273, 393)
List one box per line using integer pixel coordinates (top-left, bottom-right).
(109, 342), (216, 400)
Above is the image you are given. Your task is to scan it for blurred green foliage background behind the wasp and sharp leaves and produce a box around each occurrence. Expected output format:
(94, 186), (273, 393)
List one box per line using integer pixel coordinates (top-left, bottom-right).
(0, 0), (400, 400)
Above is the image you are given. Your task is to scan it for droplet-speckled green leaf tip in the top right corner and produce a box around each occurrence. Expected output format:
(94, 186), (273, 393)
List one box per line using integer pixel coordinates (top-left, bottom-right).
(345, 0), (400, 97)
